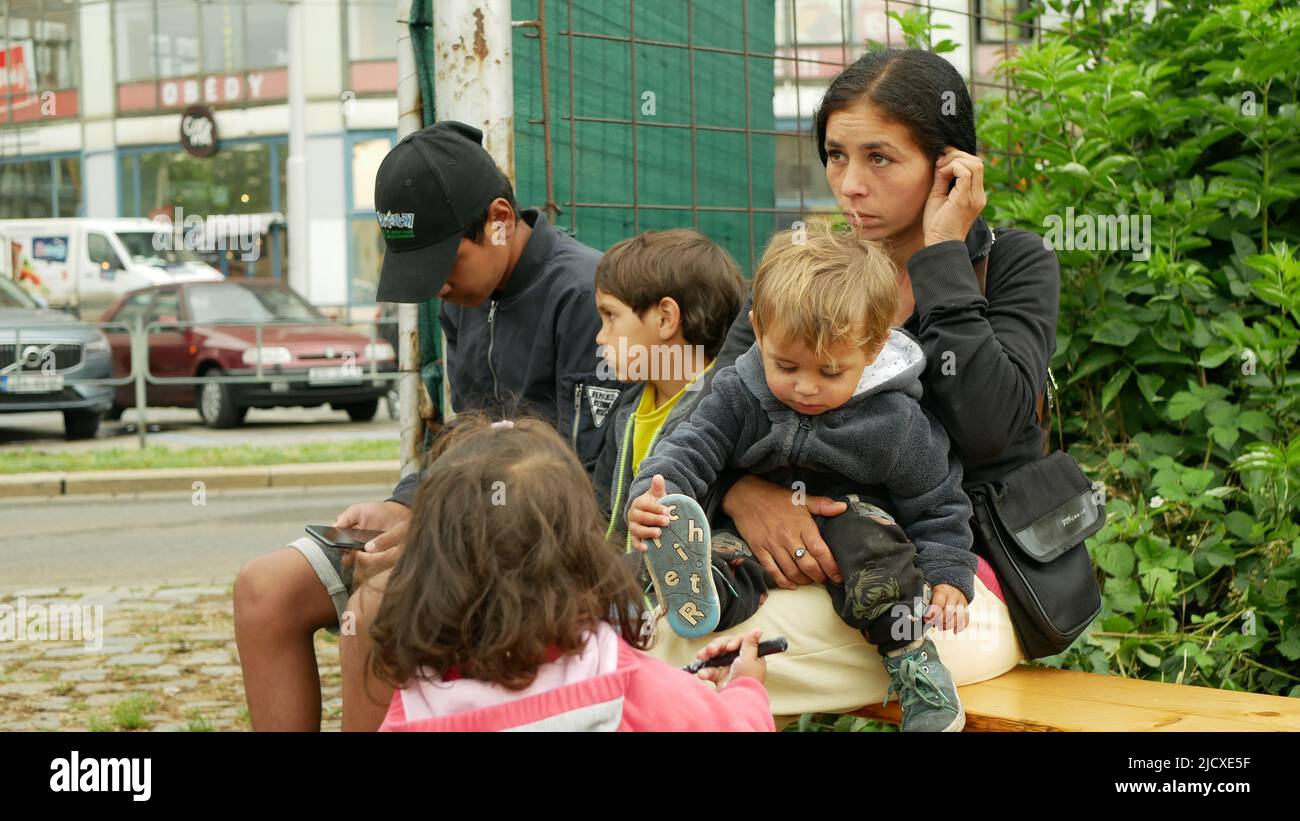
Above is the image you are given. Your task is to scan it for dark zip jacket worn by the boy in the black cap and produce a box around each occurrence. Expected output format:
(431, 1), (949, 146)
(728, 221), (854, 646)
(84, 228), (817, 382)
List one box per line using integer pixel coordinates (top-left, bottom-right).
(390, 208), (627, 507)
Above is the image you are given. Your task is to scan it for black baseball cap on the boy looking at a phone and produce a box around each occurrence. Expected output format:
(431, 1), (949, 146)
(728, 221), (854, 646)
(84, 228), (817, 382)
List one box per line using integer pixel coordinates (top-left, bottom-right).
(374, 120), (506, 303)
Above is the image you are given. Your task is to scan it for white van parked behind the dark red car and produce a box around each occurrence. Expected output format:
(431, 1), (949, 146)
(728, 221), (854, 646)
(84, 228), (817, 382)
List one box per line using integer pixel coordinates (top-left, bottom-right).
(0, 217), (222, 317)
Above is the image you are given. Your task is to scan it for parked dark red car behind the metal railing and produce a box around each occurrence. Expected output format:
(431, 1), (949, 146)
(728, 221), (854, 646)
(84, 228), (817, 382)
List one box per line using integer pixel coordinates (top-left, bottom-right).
(103, 279), (397, 427)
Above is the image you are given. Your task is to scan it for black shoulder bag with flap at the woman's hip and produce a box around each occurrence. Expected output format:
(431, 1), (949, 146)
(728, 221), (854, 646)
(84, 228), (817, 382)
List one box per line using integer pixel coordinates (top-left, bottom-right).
(967, 256), (1106, 659)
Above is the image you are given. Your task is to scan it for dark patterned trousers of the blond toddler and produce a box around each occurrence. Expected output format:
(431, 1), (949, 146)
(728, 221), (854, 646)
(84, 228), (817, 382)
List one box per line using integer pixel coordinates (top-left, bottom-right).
(712, 496), (928, 655)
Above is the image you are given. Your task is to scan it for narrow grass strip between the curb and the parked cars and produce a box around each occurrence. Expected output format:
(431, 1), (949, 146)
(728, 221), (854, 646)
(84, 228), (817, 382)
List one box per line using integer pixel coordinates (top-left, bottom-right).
(0, 438), (400, 474)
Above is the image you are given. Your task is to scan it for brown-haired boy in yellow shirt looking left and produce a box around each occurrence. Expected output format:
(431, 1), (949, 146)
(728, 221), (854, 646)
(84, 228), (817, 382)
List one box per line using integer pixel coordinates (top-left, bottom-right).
(592, 229), (770, 626)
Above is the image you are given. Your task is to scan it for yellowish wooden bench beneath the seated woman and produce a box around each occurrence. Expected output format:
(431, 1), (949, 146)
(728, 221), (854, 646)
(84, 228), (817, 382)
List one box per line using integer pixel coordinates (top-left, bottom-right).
(853, 664), (1300, 733)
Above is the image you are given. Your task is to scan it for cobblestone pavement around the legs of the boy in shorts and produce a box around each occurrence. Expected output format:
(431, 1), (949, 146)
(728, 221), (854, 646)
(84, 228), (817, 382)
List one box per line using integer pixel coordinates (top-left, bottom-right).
(0, 585), (342, 731)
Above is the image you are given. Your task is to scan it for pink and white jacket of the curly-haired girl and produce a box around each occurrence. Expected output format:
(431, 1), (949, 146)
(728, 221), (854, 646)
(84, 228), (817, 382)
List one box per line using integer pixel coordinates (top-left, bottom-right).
(380, 622), (776, 733)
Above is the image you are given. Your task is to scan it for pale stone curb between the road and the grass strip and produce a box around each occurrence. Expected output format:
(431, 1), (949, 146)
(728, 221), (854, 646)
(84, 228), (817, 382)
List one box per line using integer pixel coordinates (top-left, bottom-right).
(0, 460), (400, 499)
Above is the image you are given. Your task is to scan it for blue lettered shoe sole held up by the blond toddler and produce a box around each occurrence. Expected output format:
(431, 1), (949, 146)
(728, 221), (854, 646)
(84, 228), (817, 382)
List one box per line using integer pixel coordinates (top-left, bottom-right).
(646, 494), (722, 639)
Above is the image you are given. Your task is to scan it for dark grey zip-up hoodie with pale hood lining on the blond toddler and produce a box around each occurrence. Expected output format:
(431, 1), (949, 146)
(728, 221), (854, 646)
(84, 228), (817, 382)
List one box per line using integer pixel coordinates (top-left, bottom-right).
(623, 329), (976, 601)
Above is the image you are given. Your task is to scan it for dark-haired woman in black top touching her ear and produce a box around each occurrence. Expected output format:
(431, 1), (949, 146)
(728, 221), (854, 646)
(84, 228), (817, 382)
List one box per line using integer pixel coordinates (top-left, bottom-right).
(644, 49), (1060, 714)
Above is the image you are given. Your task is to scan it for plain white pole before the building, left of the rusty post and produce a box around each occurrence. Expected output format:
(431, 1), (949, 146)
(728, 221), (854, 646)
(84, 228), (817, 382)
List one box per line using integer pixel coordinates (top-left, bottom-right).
(285, 0), (312, 301)
